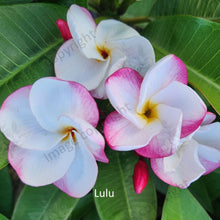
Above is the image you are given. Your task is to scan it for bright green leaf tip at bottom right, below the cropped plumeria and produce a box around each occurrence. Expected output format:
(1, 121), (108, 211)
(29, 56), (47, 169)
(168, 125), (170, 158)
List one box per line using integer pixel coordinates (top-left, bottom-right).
(162, 186), (211, 220)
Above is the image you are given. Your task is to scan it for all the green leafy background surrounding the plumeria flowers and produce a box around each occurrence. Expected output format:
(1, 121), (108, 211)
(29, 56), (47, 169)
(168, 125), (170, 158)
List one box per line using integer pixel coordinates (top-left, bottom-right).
(0, 0), (220, 220)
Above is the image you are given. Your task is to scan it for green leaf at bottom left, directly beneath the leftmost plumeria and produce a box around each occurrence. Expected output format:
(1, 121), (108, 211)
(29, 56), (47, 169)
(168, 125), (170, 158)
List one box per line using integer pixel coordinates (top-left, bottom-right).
(12, 185), (79, 220)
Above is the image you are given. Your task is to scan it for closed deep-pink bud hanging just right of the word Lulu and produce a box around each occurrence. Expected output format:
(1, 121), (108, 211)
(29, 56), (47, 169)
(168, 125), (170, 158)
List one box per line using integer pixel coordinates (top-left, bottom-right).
(133, 159), (149, 194)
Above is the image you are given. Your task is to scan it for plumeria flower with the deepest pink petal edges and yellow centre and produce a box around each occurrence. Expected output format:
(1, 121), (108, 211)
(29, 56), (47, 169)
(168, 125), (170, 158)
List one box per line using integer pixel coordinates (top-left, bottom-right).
(104, 55), (206, 158)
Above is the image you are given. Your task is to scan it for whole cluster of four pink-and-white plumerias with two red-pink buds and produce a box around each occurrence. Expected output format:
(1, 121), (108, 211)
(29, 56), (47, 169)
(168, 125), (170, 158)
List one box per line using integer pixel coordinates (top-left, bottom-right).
(0, 5), (220, 197)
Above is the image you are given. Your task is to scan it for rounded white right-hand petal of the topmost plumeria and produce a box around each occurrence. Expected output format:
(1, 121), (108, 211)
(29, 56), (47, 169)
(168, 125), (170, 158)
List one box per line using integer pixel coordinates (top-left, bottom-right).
(112, 36), (155, 76)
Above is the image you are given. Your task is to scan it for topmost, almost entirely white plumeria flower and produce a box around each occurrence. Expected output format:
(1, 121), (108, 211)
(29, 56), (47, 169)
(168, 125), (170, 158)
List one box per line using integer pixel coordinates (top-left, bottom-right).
(55, 5), (155, 98)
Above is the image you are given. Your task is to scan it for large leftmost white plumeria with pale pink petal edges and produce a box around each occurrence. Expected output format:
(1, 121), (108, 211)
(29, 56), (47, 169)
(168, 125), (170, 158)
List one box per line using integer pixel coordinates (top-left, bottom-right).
(0, 77), (108, 197)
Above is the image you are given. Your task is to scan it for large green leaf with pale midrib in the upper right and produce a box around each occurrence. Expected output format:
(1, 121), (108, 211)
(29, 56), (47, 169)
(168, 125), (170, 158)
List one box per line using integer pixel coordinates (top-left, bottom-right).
(143, 16), (220, 113)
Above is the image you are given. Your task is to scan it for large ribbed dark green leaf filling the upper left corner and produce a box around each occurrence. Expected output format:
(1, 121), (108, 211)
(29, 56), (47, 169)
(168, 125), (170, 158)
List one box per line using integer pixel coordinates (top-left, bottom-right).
(0, 3), (67, 168)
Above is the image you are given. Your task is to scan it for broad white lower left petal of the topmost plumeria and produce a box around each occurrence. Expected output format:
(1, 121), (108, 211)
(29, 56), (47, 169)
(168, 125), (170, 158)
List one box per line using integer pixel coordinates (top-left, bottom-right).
(54, 39), (110, 90)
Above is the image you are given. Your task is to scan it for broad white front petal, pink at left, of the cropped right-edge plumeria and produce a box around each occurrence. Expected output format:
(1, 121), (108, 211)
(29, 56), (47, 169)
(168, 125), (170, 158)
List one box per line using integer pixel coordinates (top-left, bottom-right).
(151, 140), (205, 188)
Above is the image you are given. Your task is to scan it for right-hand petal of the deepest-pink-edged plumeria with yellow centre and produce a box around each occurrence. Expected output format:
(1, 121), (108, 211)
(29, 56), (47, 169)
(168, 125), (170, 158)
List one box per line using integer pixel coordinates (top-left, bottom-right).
(151, 81), (206, 138)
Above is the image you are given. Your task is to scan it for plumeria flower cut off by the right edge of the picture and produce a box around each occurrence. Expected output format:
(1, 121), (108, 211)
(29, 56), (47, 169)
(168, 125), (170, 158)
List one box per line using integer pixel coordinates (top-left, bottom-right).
(151, 113), (220, 188)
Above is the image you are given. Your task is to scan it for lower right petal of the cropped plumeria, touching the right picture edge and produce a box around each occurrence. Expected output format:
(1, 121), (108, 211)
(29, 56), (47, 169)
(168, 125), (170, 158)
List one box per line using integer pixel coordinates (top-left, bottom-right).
(198, 145), (220, 175)
